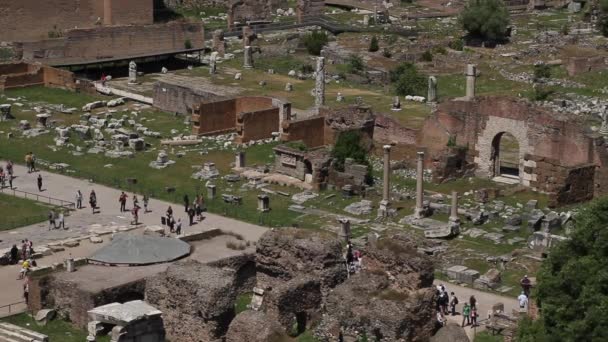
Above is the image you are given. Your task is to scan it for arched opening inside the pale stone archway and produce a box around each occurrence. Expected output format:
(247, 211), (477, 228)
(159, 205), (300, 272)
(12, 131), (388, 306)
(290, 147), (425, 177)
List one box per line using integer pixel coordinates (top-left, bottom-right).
(491, 132), (521, 182)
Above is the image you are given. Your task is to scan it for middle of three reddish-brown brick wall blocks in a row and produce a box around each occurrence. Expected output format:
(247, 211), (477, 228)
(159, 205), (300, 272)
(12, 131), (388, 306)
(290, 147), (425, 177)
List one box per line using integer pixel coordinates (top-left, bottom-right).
(235, 108), (279, 144)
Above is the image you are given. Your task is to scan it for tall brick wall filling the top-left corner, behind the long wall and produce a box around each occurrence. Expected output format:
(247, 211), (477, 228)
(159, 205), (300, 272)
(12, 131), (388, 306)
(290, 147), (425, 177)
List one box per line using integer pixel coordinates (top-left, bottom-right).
(0, 0), (153, 41)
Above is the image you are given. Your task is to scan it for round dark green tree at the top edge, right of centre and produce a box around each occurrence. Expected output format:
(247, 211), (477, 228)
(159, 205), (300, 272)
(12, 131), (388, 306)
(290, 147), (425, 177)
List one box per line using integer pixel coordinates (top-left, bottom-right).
(458, 0), (509, 41)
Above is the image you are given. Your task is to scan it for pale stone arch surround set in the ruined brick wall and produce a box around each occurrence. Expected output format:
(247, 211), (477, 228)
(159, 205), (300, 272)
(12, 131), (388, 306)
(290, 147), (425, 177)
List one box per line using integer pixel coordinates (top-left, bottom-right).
(475, 116), (533, 184)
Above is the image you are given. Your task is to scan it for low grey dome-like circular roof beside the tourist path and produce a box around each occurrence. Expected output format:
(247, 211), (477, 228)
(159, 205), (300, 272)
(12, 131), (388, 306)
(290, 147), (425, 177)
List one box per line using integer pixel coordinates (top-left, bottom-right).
(89, 234), (191, 266)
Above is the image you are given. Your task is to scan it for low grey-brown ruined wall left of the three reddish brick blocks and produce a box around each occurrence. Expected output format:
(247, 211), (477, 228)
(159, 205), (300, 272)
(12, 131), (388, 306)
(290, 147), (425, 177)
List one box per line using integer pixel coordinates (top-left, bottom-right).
(153, 82), (223, 115)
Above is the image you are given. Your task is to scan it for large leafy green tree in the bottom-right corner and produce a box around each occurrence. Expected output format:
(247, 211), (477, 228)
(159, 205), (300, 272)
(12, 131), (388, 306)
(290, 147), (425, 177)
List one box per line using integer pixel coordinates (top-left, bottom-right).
(518, 197), (608, 342)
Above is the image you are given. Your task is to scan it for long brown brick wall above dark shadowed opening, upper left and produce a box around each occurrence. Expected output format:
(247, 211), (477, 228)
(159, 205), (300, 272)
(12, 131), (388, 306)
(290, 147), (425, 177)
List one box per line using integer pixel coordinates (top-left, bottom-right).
(21, 22), (204, 63)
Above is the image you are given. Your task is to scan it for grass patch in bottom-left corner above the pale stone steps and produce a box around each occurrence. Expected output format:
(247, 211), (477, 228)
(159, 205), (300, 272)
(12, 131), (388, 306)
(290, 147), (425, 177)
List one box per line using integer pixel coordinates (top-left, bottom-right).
(2, 313), (110, 342)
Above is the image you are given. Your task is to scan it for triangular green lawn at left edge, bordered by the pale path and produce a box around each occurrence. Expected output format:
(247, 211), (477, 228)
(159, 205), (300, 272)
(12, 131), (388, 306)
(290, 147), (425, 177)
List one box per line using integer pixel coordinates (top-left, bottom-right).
(0, 190), (50, 230)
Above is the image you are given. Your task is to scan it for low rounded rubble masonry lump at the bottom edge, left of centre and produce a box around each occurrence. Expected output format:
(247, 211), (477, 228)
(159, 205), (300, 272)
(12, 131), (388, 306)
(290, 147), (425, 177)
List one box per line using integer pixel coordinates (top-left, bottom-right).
(226, 310), (288, 342)
